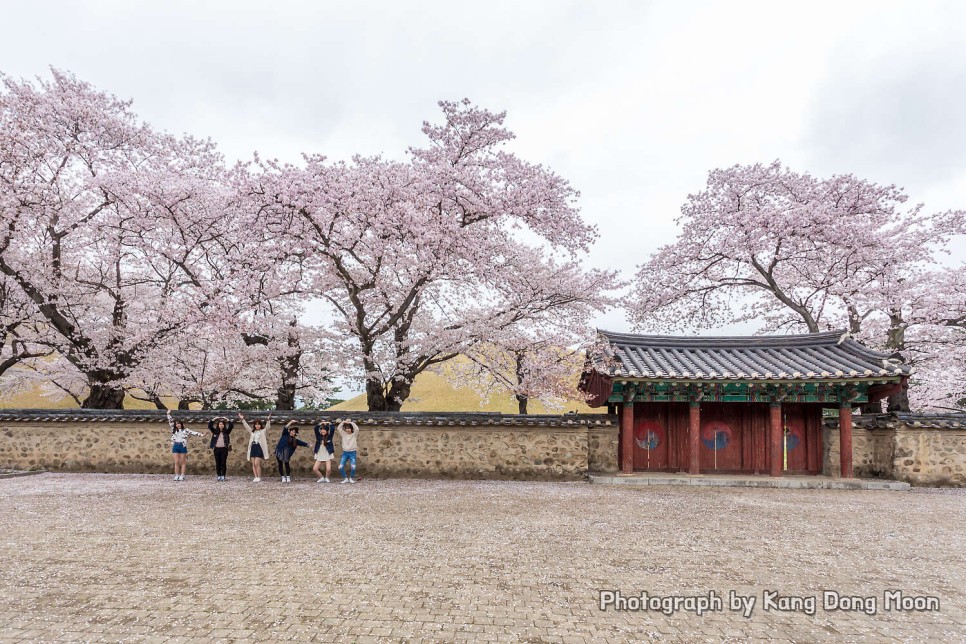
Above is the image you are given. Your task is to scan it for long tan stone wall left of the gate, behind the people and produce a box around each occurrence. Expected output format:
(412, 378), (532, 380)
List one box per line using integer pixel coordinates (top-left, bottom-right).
(0, 410), (617, 480)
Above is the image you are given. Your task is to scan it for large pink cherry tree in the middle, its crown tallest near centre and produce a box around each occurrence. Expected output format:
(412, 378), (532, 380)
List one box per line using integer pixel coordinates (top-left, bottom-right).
(249, 101), (612, 411)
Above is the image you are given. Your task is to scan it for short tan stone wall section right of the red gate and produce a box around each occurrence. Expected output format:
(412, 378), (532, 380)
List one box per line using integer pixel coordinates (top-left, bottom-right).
(823, 413), (966, 487)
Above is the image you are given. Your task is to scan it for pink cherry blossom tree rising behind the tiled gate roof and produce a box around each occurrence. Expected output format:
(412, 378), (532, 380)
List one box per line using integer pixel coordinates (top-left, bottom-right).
(629, 161), (964, 409)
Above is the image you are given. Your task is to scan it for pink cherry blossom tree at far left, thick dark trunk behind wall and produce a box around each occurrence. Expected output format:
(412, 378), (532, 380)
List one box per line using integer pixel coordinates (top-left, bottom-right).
(0, 70), (233, 408)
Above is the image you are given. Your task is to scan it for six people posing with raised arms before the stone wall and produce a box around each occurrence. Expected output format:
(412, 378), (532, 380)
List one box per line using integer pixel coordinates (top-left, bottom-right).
(168, 411), (359, 483)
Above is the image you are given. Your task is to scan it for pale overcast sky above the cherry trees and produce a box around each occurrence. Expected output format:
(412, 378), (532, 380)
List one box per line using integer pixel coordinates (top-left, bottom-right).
(0, 0), (966, 392)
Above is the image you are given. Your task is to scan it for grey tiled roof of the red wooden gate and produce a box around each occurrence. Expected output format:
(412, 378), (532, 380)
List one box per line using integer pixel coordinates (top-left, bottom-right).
(586, 331), (911, 381)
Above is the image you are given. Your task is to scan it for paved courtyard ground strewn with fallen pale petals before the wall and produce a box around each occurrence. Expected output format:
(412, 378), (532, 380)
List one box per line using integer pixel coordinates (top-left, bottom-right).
(0, 474), (966, 642)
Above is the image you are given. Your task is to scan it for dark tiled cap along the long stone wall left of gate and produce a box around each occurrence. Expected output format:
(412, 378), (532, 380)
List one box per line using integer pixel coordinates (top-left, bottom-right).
(0, 409), (617, 427)
